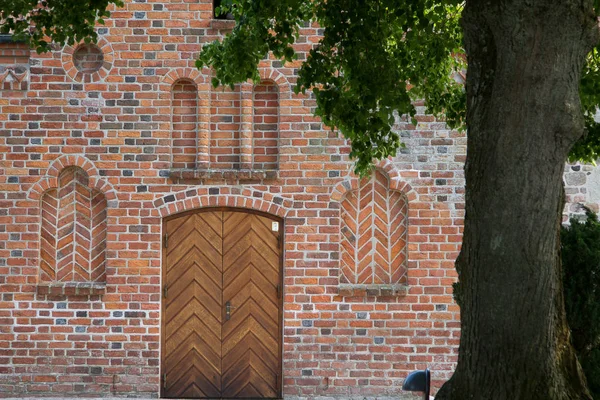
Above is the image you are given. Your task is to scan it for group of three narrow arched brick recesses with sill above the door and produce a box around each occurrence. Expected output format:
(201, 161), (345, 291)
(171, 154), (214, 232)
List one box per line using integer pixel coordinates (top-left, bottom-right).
(161, 67), (290, 181)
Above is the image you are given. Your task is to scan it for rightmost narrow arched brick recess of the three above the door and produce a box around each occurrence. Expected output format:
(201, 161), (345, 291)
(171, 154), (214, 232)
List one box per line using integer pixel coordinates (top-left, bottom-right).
(252, 79), (279, 170)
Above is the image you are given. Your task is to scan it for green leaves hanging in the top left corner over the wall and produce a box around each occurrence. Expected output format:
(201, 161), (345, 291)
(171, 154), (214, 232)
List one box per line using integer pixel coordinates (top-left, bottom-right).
(0, 0), (123, 53)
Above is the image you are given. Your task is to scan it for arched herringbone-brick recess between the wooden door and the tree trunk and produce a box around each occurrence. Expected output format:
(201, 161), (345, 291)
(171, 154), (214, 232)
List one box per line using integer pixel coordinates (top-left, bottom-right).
(340, 170), (408, 284)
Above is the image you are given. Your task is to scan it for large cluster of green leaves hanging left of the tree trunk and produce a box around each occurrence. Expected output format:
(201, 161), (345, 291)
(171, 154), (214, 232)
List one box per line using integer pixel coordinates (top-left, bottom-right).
(197, 0), (465, 174)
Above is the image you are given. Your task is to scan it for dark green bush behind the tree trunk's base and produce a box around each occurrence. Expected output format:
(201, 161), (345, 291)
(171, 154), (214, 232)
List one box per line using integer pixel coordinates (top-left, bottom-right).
(561, 209), (600, 399)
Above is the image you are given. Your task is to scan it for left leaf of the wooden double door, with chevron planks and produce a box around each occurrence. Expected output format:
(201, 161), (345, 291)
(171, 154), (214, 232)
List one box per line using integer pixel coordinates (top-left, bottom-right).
(163, 212), (223, 398)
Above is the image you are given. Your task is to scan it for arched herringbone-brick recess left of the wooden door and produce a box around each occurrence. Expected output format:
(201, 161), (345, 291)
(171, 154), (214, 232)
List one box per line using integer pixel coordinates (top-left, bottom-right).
(40, 166), (107, 284)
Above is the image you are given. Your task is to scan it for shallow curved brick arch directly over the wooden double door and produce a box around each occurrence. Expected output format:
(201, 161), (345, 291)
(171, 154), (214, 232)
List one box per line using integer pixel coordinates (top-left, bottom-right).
(154, 186), (293, 218)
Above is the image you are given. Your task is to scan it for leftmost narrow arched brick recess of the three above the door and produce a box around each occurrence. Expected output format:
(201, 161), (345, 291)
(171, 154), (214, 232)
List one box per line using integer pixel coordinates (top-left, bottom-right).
(171, 79), (198, 169)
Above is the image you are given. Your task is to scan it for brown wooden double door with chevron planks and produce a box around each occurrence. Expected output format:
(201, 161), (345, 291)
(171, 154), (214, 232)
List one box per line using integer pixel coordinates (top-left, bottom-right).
(162, 209), (282, 398)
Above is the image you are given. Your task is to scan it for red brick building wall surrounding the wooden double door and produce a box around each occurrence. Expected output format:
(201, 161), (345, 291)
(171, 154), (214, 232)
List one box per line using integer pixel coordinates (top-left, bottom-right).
(0, 0), (592, 398)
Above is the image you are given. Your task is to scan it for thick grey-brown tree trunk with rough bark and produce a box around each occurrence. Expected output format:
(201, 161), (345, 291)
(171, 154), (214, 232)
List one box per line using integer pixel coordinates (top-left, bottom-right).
(436, 0), (598, 400)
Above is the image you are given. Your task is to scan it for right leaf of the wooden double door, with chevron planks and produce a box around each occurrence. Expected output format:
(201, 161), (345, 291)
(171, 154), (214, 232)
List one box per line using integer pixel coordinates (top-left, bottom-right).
(222, 213), (281, 398)
